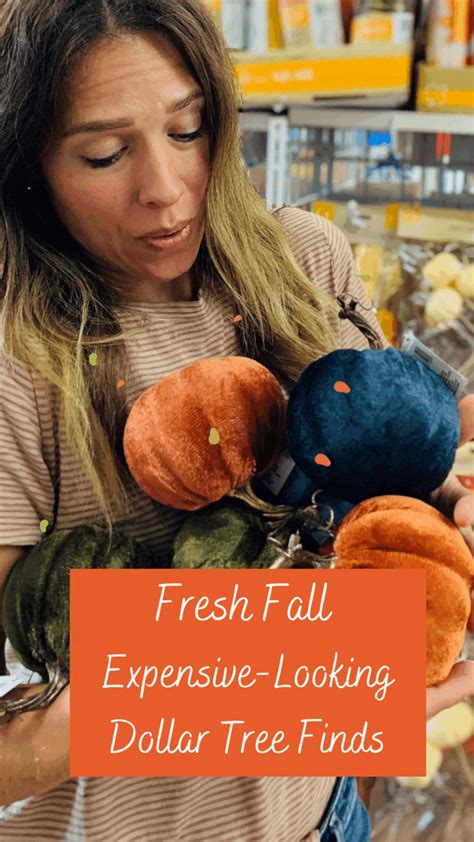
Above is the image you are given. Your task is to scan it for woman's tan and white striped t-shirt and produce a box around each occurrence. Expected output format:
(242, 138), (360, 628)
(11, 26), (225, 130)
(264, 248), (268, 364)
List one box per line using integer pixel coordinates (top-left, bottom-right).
(0, 208), (386, 842)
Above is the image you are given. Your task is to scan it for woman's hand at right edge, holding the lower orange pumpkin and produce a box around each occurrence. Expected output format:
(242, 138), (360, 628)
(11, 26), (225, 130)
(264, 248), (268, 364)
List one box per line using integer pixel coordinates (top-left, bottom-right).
(426, 395), (474, 719)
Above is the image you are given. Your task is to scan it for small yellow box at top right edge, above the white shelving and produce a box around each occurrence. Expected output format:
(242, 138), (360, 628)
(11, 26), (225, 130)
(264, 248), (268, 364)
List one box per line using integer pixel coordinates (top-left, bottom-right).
(416, 64), (474, 116)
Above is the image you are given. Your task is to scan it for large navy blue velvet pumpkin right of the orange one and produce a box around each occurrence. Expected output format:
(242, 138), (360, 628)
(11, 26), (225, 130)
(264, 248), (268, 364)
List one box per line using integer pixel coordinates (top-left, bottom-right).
(287, 348), (460, 503)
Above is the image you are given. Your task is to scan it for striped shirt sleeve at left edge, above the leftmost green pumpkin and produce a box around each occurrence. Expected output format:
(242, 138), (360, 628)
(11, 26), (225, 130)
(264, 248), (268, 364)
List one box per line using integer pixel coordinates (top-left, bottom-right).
(0, 350), (54, 546)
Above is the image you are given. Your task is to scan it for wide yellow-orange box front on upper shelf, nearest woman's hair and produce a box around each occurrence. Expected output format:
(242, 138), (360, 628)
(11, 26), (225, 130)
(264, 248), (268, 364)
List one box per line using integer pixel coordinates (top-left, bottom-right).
(233, 44), (412, 105)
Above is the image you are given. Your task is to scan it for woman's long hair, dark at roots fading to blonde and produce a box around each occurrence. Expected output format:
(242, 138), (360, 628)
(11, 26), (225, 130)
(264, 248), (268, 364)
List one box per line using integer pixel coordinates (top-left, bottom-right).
(0, 0), (336, 525)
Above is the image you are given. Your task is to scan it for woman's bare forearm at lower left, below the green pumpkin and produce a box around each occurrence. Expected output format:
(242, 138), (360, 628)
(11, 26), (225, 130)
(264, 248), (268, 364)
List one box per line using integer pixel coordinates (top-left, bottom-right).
(0, 684), (70, 807)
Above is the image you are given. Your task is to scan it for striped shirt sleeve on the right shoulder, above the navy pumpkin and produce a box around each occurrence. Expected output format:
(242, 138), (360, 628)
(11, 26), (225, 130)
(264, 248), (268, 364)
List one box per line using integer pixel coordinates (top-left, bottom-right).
(314, 215), (389, 351)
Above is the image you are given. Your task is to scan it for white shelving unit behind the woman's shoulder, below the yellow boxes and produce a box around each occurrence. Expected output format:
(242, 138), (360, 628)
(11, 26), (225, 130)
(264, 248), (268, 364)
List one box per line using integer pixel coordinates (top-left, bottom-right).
(241, 103), (474, 210)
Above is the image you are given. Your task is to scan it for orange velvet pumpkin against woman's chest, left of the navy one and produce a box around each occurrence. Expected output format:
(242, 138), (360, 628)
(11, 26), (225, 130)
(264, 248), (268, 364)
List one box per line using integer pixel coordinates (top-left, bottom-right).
(124, 357), (286, 510)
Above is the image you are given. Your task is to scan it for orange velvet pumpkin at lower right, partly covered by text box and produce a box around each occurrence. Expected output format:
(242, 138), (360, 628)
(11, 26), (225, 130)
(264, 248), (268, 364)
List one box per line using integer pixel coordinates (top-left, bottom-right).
(334, 496), (474, 687)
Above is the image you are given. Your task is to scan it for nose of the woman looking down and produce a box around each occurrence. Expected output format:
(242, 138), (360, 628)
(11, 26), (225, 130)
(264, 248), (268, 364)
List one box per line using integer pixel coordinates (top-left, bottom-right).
(138, 148), (184, 207)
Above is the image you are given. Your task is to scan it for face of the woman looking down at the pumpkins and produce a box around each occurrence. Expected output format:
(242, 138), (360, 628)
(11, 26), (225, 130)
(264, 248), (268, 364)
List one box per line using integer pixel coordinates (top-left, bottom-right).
(43, 35), (209, 301)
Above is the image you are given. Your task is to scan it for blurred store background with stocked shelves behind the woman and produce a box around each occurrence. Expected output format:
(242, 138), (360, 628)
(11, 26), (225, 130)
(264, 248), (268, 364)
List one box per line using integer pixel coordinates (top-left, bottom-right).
(207, 0), (474, 842)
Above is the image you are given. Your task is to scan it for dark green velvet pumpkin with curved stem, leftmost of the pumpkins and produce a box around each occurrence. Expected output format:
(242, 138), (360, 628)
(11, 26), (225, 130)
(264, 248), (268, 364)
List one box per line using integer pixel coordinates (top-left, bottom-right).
(0, 526), (157, 713)
